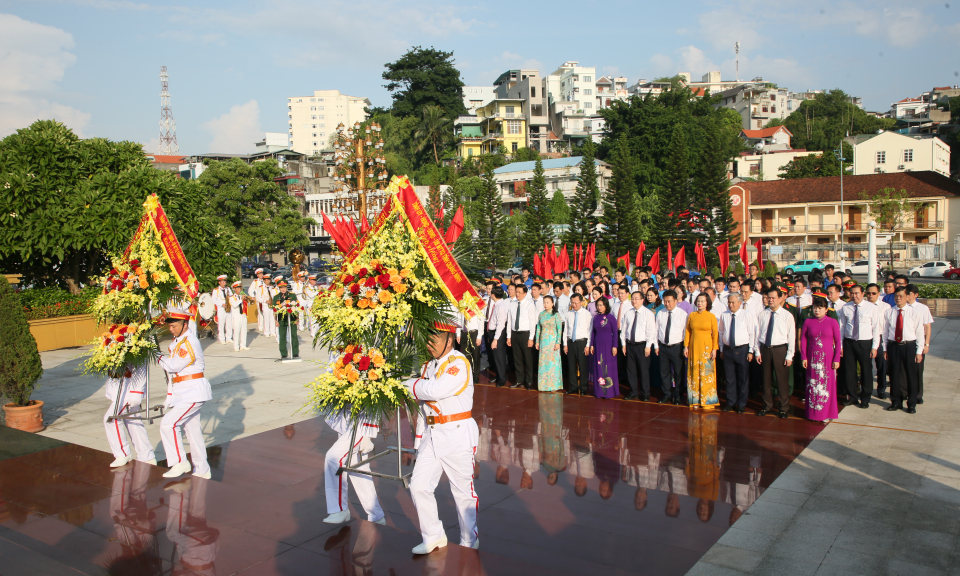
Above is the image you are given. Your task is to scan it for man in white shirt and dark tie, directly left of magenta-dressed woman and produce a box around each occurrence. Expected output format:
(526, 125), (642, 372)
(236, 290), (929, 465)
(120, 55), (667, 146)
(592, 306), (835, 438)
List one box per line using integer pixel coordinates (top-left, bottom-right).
(754, 288), (797, 418)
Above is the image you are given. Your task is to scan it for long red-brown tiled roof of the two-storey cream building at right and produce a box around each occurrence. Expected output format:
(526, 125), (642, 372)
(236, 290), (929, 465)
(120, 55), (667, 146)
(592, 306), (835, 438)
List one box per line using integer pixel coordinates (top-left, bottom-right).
(739, 171), (960, 205)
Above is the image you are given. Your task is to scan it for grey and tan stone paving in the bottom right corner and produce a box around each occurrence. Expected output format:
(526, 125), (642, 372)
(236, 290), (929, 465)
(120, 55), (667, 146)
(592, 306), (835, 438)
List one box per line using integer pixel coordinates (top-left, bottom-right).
(687, 318), (960, 576)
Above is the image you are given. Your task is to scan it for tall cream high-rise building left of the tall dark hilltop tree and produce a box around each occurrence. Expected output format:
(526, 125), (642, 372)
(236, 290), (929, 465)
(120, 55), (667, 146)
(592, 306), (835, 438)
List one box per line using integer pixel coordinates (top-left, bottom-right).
(287, 90), (370, 155)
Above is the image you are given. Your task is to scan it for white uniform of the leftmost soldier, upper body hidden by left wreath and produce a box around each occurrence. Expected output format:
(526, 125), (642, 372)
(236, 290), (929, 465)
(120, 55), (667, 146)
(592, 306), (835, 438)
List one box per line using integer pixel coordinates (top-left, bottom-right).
(103, 364), (154, 462)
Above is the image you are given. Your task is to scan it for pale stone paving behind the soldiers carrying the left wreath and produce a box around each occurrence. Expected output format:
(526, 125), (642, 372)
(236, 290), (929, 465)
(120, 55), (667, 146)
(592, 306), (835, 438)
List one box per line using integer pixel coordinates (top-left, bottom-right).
(25, 324), (327, 460)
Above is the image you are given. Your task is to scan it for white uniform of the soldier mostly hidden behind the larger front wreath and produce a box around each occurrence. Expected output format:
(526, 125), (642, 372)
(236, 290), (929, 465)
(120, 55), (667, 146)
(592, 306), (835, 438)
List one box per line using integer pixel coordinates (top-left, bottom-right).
(323, 415), (383, 522)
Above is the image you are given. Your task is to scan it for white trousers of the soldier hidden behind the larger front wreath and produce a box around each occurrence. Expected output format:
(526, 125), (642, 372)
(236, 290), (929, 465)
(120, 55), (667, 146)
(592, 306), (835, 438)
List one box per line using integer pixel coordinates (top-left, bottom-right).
(323, 434), (383, 522)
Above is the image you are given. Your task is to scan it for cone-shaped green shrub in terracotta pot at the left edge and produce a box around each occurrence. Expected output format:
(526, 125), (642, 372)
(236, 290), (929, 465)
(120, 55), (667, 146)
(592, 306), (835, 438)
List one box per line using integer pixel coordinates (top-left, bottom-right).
(0, 276), (45, 432)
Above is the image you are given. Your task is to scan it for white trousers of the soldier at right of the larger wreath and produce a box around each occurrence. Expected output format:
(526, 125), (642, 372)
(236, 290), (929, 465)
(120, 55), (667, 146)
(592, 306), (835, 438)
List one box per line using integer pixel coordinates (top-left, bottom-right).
(410, 441), (480, 546)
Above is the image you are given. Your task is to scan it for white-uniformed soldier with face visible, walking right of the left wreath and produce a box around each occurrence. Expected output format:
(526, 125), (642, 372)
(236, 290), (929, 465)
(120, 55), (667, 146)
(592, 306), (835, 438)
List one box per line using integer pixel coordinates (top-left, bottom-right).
(160, 305), (213, 478)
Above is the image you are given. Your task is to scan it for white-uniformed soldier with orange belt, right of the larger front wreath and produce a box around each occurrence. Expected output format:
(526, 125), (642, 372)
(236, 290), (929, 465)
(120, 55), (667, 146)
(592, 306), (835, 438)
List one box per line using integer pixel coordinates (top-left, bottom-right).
(403, 325), (480, 554)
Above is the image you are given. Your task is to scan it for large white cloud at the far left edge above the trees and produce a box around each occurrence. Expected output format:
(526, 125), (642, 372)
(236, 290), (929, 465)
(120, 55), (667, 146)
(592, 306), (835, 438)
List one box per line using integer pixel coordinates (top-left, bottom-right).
(0, 14), (90, 136)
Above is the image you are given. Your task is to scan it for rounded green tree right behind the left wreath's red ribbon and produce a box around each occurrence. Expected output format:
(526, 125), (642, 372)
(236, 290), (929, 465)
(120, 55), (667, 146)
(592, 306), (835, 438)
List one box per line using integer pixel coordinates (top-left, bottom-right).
(196, 158), (314, 256)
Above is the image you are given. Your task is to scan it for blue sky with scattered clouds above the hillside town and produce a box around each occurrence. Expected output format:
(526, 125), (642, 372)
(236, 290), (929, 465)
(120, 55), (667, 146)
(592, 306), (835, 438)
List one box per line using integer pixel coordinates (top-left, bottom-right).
(0, 0), (960, 153)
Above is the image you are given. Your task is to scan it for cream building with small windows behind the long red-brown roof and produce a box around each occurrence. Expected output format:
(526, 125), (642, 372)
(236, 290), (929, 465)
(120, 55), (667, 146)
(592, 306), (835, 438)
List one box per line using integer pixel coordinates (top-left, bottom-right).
(845, 131), (950, 176)
